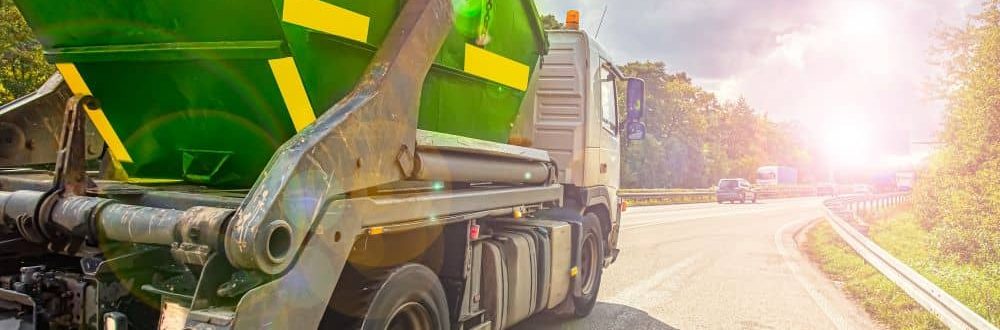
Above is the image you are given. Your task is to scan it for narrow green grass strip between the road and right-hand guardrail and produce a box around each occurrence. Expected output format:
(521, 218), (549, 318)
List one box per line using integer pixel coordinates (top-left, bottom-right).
(805, 222), (946, 329)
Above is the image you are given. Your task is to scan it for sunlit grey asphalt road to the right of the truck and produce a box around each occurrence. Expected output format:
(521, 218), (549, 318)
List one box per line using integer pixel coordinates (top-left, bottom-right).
(516, 198), (879, 329)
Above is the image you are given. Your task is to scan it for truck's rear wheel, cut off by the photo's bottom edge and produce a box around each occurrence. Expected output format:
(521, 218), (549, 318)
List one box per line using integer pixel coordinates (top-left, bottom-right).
(360, 264), (451, 330)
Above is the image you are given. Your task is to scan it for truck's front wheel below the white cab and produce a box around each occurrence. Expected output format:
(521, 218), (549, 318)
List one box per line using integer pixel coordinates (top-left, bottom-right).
(573, 213), (604, 317)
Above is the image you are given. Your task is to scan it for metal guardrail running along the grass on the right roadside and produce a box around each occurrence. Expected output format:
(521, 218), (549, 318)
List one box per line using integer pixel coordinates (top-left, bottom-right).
(824, 193), (997, 330)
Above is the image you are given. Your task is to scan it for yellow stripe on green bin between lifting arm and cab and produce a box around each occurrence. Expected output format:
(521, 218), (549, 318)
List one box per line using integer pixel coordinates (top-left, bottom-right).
(465, 44), (530, 91)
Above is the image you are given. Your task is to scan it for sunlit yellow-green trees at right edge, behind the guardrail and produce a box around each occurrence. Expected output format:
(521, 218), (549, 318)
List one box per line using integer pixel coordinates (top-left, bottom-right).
(914, 0), (1000, 265)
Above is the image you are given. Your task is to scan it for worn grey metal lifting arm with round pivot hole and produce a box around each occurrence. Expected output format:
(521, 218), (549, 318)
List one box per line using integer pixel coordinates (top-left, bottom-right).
(225, 0), (453, 274)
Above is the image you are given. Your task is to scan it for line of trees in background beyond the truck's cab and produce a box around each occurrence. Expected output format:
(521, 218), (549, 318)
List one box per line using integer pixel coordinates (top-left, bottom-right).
(542, 15), (825, 188)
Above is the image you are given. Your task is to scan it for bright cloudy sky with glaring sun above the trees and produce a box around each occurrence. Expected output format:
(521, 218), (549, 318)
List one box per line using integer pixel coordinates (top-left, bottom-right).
(536, 0), (979, 166)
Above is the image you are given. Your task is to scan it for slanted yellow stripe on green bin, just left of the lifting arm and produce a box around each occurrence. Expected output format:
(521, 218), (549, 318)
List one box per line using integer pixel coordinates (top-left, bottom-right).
(267, 57), (316, 131)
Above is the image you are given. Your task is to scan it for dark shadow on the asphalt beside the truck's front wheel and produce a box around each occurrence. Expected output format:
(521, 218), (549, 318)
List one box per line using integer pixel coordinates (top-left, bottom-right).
(513, 302), (677, 330)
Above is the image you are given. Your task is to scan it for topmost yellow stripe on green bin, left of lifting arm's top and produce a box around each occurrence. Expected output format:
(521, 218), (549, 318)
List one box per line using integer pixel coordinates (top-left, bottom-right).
(281, 0), (371, 42)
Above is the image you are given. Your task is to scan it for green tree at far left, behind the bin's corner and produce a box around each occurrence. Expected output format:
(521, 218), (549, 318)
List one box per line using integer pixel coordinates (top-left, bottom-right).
(0, 0), (54, 104)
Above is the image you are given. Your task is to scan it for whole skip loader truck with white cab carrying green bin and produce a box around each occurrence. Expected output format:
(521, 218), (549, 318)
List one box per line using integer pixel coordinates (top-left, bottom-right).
(0, 0), (645, 330)
